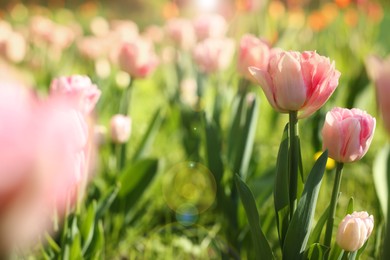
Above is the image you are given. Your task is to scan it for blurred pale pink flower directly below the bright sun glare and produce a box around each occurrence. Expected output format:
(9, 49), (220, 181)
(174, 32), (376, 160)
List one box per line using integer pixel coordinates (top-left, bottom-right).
(194, 14), (227, 41)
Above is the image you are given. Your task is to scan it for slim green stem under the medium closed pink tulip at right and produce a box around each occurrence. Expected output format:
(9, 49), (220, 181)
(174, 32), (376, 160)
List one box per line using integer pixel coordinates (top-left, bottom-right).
(324, 162), (344, 259)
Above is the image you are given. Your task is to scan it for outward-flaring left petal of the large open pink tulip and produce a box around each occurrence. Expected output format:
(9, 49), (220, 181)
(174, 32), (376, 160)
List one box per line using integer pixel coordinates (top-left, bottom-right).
(248, 67), (288, 113)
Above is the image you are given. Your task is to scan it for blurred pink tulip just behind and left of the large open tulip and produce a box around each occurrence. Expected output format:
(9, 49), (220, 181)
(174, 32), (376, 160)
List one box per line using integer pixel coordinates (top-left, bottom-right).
(237, 34), (271, 80)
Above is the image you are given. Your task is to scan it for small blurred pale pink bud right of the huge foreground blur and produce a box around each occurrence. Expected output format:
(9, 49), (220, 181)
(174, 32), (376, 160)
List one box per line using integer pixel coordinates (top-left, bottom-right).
(110, 114), (131, 144)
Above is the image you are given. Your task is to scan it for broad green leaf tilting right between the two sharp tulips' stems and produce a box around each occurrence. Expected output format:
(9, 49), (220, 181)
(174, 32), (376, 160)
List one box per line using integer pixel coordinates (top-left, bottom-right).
(283, 151), (328, 260)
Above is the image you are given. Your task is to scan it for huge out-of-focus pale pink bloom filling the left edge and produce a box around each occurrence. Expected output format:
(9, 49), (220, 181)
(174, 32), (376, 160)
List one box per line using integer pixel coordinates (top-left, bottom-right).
(0, 82), (97, 252)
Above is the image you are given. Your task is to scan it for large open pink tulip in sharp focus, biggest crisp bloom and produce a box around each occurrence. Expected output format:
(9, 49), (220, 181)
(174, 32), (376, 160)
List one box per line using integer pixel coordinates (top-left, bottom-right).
(249, 51), (340, 118)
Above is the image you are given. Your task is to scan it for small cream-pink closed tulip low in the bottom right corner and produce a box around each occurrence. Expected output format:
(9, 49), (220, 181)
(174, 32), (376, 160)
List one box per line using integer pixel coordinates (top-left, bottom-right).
(336, 211), (374, 252)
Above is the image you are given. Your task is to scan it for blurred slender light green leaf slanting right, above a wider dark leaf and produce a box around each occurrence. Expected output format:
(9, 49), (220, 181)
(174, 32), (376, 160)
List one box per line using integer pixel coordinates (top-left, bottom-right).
(132, 108), (164, 161)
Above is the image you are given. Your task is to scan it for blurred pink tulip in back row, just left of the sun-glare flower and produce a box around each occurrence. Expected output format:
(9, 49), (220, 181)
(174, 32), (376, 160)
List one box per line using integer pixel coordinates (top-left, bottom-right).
(166, 18), (196, 50)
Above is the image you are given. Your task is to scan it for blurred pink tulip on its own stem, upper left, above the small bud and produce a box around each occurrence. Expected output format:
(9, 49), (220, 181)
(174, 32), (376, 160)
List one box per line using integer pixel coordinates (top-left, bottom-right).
(118, 38), (158, 78)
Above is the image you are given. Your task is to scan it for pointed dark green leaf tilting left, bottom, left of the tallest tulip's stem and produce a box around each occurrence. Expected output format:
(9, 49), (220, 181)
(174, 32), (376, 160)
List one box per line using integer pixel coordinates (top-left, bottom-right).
(235, 174), (274, 260)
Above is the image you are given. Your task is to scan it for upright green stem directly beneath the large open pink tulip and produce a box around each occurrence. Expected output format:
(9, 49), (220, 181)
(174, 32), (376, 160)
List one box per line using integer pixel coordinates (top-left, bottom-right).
(289, 111), (299, 219)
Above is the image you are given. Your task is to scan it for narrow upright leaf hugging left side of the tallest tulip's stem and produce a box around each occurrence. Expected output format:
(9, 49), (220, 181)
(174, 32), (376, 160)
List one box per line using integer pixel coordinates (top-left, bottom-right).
(274, 124), (289, 248)
